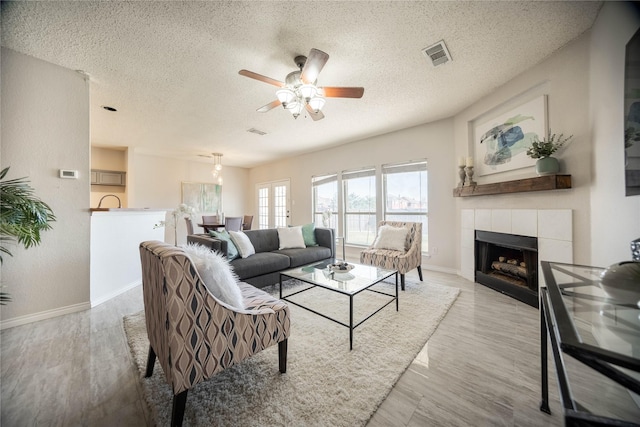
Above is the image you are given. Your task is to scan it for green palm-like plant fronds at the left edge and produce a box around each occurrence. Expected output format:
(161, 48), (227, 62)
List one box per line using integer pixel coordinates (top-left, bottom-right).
(0, 167), (56, 305)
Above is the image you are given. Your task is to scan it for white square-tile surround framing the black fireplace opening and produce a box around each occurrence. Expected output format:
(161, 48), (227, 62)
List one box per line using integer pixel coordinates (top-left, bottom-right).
(460, 209), (573, 286)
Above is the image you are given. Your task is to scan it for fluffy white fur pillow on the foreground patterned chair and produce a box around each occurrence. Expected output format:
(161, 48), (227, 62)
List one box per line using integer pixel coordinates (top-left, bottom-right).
(182, 244), (244, 309)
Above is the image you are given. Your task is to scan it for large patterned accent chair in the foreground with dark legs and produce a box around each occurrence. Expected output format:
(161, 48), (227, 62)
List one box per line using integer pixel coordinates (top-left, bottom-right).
(140, 241), (290, 426)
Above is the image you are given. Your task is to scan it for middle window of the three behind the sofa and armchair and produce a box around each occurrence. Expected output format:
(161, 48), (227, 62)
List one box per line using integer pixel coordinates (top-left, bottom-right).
(342, 169), (377, 245)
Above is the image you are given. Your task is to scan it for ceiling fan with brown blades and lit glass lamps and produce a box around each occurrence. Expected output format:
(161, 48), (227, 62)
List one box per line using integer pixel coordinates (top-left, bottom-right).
(238, 49), (364, 120)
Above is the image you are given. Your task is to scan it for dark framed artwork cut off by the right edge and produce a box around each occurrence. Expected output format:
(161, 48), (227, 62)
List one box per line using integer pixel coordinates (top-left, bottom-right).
(624, 30), (640, 196)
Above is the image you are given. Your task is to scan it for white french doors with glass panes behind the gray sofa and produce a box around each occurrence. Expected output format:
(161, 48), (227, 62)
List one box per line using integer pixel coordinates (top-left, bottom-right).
(256, 179), (291, 229)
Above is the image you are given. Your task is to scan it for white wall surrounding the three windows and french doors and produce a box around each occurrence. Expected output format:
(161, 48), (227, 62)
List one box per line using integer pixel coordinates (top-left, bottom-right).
(248, 119), (457, 270)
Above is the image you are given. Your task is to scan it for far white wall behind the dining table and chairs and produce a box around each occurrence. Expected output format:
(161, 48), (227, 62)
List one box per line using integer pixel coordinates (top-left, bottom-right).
(128, 150), (254, 244)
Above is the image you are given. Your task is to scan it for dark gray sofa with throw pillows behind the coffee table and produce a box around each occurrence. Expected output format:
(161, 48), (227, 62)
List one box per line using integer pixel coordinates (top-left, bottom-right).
(187, 228), (336, 288)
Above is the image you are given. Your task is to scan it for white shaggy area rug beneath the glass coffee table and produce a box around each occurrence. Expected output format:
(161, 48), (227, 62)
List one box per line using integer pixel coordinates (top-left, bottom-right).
(124, 281), (460, 426)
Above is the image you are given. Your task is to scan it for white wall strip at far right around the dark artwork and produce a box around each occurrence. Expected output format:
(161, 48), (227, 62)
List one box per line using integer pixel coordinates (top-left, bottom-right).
(589, 2), (640, 266)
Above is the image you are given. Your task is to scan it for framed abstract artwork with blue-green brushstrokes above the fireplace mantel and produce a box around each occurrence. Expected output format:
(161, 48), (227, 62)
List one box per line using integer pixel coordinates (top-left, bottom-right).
(473, 95), (547, 176)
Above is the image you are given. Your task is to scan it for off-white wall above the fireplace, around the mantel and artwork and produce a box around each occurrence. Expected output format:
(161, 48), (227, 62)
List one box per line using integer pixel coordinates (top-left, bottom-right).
(450, 24), (593, 265)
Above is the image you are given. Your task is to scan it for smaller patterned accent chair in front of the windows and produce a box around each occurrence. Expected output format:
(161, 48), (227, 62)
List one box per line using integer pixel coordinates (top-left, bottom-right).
(360, 221), (422, 291)
